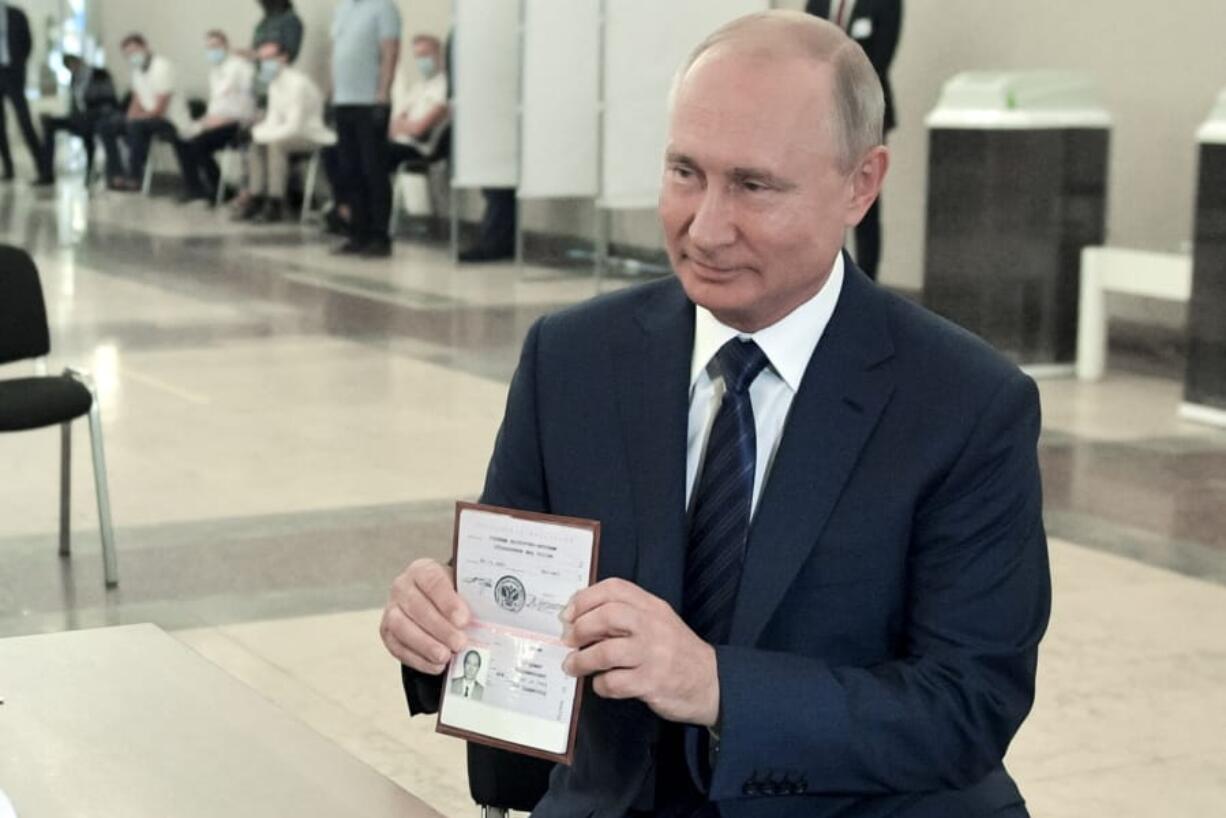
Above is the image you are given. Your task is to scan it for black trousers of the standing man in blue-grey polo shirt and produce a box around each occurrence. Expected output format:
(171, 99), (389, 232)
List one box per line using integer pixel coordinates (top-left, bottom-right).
(336, 105), (391, 244)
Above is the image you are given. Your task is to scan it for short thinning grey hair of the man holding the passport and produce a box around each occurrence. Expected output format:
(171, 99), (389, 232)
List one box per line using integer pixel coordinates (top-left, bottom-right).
(672, 9), (885, 173)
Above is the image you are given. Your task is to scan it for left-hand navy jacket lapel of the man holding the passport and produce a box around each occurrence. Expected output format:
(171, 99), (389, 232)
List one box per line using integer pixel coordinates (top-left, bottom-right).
(614, 280), (694, 608)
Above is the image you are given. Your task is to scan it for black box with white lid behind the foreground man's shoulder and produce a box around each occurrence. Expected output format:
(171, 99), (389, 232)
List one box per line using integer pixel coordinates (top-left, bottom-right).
(923, 71), (1111, 374)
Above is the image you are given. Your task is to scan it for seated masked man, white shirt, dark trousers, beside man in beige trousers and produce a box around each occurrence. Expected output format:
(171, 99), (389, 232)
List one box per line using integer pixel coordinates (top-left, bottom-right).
(183, 29), (255, 201)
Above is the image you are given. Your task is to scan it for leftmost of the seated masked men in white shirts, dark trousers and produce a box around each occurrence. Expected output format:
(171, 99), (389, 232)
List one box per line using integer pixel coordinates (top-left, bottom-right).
(98, 34), (191, 190)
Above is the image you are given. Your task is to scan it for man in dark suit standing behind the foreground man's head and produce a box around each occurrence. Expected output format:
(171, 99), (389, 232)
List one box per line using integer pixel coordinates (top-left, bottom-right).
(804, 0), (902, 280)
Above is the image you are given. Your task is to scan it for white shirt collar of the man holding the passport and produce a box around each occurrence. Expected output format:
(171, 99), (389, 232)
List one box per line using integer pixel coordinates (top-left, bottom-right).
(690, 253), (843, 392)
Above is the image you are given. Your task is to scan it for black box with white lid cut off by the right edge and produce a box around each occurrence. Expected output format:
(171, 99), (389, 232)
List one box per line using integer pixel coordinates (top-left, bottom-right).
(1183, 91), (1226, 426)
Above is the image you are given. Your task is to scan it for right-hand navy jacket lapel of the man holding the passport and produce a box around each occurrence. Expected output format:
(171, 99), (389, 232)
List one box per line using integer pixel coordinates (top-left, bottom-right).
(729, 259), (894, 645)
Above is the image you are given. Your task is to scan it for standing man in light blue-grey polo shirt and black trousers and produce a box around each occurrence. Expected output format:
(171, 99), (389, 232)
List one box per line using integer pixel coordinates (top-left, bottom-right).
(332, 0), (401, 258)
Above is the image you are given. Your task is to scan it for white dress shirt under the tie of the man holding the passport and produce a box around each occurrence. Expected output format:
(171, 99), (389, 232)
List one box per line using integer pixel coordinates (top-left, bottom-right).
(685, 253), (843, 514)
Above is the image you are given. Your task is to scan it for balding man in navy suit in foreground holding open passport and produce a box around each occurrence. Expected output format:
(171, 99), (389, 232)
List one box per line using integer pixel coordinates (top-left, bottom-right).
(381, 11), (1051, 818)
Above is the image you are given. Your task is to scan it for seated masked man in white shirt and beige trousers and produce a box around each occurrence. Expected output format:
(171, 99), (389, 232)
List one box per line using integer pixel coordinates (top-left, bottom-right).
(237, 43), (336, 223)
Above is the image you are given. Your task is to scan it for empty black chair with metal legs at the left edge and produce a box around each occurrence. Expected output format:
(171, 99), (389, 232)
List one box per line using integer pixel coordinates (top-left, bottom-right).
(0, 244), (119, 587)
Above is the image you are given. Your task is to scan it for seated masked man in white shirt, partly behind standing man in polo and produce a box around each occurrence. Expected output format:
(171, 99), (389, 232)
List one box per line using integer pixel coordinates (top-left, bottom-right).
(324, 34), (451, 234)
